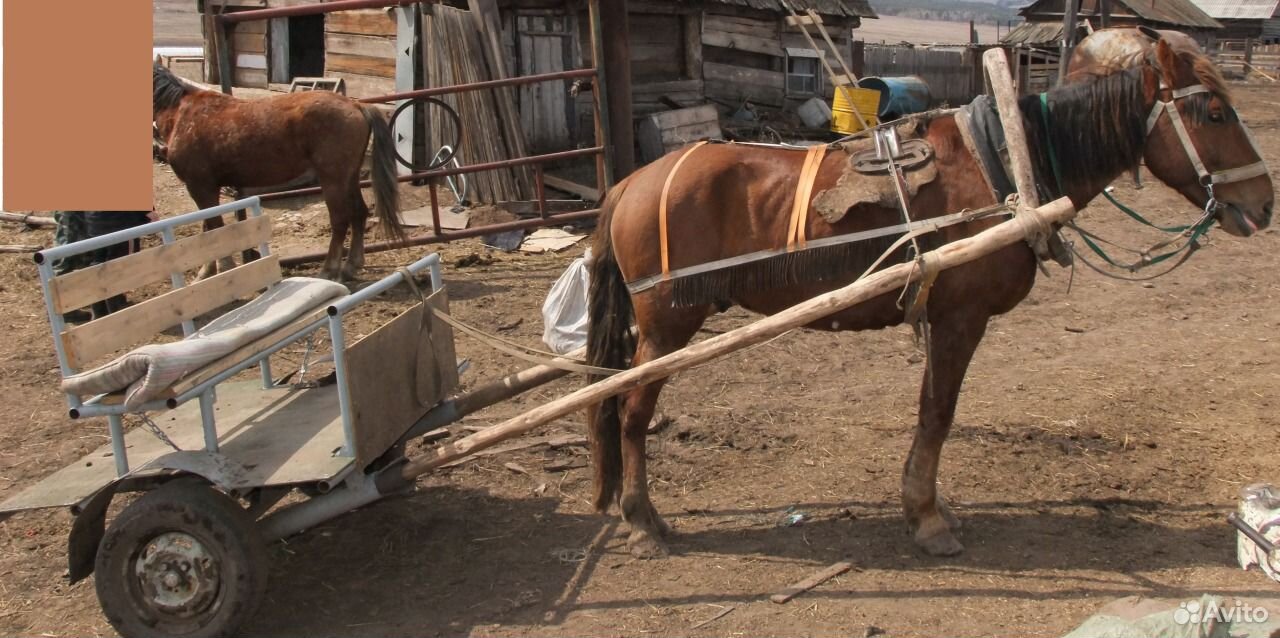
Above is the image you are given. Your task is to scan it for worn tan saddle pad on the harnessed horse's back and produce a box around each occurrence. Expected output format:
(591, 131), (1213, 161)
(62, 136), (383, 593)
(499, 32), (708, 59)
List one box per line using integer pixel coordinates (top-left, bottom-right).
(813, 118), (938, 224)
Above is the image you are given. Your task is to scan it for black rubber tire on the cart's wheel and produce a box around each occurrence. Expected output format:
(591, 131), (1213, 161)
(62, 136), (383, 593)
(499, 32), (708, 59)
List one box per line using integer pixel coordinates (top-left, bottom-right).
(93, 479), (268, 638)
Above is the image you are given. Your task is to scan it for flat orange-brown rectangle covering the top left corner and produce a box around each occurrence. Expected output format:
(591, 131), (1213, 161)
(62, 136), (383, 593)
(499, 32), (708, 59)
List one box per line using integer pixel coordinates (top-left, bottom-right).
(4, 0), (152, 210)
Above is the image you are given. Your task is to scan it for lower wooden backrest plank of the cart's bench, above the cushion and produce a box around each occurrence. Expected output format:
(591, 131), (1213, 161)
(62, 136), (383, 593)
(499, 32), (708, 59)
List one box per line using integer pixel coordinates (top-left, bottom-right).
(61, 255), (280, 369)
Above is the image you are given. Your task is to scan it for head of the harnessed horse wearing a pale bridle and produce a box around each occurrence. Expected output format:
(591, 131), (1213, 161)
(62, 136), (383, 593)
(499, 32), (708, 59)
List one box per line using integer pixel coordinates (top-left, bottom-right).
(1143, 36), (1275, 237)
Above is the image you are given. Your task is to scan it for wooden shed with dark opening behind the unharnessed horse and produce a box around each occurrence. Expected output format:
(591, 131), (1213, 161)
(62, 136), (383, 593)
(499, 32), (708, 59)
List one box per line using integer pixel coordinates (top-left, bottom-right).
(197, 0), (396, 97)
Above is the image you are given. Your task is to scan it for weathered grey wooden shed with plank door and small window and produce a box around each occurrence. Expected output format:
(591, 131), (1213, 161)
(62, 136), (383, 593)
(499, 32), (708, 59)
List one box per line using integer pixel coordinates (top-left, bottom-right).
(499, 0), (876, 150)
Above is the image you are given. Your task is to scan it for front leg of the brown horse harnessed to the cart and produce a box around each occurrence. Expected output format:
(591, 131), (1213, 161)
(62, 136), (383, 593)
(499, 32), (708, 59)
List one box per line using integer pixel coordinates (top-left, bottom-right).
(902, 315), (987, 556)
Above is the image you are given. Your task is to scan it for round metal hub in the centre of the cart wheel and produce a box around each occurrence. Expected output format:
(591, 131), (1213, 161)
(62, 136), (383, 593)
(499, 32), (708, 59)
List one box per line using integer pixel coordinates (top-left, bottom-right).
(133, 532), (220, 616)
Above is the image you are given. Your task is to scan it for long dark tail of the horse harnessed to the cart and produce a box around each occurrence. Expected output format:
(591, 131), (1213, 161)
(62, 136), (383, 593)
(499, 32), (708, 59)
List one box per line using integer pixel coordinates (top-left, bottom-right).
(586, 179), (635, 514)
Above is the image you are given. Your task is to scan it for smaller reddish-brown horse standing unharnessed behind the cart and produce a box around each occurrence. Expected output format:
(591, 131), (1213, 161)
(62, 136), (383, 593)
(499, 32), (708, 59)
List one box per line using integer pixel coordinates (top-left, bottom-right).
(152, 63), (404, 279)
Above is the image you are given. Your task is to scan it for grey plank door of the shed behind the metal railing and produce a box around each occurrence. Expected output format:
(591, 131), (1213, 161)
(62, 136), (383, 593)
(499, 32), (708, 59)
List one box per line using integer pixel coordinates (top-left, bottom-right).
(516, 15), (573, 152)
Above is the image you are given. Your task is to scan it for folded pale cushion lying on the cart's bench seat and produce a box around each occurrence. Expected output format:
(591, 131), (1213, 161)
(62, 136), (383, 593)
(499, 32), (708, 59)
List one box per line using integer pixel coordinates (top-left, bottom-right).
(61, 277), (347, 410)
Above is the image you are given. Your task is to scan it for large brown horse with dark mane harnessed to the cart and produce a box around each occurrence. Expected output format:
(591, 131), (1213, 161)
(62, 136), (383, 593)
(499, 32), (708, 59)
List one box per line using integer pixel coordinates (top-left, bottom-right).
(588, 36), (1275, 556)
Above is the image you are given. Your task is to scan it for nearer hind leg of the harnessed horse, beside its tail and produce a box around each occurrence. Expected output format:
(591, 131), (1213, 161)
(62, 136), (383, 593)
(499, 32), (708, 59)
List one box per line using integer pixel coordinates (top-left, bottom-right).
(620, 307), (707, 559)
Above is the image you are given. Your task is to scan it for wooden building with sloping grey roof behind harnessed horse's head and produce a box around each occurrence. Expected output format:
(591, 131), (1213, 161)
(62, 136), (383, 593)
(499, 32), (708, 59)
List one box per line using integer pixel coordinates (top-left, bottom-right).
(1000, 0), (1222, 46)
